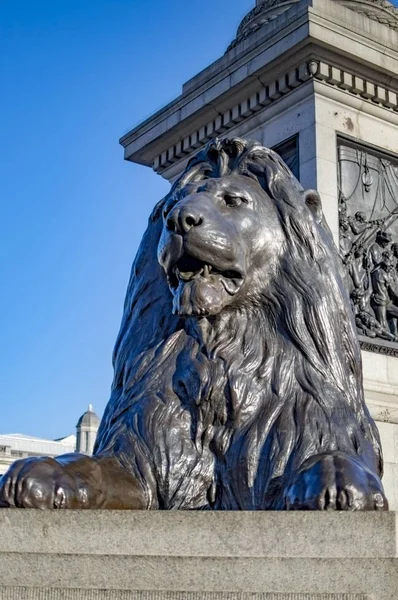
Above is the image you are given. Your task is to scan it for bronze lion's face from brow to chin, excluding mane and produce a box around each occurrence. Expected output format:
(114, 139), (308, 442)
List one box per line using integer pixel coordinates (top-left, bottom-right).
(158, 174), (284, 316)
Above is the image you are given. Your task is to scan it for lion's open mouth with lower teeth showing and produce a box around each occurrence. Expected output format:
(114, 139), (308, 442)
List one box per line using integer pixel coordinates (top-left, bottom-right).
(168, 255), (243, 294)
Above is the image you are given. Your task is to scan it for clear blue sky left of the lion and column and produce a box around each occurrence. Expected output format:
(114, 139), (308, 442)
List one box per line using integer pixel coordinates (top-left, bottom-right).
(0, 0), (255, 437)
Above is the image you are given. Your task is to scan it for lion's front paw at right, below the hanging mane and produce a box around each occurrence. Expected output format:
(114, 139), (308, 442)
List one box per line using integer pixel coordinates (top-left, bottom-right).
(285, 453), (388, 510)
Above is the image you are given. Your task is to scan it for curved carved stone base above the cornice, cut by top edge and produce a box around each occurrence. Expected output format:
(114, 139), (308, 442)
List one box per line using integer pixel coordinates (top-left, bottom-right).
(227, 0), (398, 52)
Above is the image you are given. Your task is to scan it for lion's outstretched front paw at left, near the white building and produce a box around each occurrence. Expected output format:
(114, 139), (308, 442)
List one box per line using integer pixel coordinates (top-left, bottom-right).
(0, 457), (87, 508)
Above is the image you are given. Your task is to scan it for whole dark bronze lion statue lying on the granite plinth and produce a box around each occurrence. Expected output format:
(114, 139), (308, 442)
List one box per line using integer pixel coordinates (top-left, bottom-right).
(0, 139), (388, 510)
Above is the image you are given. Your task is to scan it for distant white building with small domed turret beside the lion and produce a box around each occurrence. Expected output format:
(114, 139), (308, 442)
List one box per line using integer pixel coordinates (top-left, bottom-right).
(0, 404), (100, 476)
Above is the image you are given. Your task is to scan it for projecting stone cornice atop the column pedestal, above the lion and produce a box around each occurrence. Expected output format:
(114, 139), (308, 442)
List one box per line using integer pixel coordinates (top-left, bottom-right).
(120, 0), (398, 172)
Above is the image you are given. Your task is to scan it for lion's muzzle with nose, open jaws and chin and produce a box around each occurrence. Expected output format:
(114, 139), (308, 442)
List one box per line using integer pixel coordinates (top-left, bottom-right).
(158, 193), (245, 316)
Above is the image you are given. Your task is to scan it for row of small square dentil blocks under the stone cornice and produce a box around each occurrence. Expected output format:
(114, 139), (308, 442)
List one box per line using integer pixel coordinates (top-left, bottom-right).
(153, 59), (398, 173)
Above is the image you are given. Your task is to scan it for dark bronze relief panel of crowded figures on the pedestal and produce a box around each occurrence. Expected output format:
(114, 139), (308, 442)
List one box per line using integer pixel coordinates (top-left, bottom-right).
(337, 140), (398, 356)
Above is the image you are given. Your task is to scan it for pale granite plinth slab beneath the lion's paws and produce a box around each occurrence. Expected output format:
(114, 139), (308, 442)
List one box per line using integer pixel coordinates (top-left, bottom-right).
(0, 510), (398, 600)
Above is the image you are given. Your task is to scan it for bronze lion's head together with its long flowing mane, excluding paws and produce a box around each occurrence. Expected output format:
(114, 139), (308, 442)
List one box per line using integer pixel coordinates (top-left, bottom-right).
(97, 139), (382, 488)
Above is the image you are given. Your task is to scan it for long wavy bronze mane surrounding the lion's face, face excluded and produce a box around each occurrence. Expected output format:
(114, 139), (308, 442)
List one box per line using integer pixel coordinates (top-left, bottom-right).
(95, 139), (382, 508)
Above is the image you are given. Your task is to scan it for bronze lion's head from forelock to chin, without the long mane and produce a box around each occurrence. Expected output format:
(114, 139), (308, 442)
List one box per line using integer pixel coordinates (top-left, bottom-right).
(158, 139), (330, 316)
